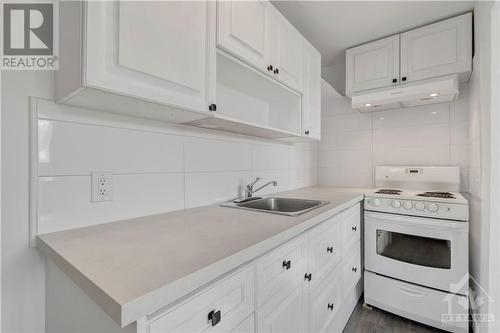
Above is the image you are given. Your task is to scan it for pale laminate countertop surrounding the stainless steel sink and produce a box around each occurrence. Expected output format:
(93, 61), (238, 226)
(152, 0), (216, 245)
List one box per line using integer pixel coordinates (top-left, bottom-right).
(37, 187), (365, 327)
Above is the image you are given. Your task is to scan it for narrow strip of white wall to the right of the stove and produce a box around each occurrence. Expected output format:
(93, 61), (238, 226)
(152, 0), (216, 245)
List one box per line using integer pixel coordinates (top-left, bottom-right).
(469, 2), (500, 332)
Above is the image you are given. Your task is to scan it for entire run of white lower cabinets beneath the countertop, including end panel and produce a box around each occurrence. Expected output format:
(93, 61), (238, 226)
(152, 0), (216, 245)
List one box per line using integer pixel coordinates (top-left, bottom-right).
(47, 200), (362, 333)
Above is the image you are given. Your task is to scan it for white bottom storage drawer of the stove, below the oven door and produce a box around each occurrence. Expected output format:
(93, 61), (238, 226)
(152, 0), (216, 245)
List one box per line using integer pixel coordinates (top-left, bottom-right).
(365, 271), (469, 333)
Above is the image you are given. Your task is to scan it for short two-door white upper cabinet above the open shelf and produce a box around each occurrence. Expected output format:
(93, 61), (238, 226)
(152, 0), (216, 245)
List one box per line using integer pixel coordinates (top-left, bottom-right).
(217, 0), (303, 93)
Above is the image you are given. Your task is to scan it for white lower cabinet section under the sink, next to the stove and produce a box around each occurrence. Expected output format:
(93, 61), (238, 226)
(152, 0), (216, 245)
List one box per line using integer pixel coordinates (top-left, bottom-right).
(256, 204), (362, 332)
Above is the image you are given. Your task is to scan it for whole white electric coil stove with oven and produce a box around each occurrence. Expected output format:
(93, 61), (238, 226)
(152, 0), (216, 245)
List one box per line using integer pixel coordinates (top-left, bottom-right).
(364, 166), (469, 332)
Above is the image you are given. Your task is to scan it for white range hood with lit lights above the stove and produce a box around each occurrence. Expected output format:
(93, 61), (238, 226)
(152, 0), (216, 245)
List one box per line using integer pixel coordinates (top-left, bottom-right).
(351, 75), (458, 112)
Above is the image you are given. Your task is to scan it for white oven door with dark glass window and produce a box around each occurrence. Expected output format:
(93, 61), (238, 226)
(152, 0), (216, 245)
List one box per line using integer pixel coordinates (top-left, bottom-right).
(365, 211), (469, 295)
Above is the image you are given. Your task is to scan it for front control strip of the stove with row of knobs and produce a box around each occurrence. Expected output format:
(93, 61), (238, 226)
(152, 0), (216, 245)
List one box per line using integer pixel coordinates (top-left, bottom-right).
(365, 196), (469, 221)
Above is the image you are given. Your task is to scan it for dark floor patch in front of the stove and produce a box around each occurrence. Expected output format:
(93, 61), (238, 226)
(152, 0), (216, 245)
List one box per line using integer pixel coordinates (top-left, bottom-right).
(343, 297), (444, 333)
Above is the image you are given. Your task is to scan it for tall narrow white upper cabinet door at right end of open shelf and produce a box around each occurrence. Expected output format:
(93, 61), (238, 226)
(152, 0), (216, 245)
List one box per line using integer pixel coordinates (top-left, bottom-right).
(302, 41), (321, 140)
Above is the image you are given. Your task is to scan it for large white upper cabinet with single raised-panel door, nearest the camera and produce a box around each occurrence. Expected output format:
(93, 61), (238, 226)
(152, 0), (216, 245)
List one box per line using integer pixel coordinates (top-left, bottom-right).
(56, 1), (215, 122)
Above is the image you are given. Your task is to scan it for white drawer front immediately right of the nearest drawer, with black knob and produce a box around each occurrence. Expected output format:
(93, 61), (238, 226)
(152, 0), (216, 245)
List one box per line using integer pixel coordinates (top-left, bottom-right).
(256, 236), (307, 306)
